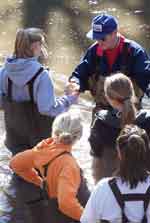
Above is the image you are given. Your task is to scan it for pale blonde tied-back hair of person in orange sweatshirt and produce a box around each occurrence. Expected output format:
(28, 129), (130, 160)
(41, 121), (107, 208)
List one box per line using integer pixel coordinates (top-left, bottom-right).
(52, 112), (83, 144)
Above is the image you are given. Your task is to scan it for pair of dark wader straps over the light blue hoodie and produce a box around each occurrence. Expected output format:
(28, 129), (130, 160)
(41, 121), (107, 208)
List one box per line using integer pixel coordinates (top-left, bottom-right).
(8, 67), (44, 102)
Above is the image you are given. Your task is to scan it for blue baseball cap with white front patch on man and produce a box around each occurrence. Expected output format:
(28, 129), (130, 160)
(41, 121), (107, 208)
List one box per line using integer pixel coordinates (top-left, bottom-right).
(86, 14), (118, 40)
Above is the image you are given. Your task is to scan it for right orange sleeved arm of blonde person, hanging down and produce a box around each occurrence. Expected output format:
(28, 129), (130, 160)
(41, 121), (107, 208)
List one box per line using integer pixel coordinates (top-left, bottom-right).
(57, 161), (83, 220)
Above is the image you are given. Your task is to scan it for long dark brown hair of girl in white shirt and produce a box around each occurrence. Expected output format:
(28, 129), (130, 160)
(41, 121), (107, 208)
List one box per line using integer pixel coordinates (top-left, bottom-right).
(116, 125), (150, 188)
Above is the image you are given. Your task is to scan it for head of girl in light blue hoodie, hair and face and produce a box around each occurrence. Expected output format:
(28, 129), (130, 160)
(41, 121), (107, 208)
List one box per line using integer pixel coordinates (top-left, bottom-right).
(14, 28), (47, 58)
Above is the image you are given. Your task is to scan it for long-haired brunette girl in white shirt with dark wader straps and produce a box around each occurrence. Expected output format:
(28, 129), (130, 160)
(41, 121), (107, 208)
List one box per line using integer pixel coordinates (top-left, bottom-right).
(81, 125), (150, 223)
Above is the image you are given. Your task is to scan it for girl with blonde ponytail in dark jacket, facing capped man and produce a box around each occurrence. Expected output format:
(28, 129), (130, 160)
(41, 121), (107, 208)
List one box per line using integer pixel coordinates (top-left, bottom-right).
(89, 73), (150, 182)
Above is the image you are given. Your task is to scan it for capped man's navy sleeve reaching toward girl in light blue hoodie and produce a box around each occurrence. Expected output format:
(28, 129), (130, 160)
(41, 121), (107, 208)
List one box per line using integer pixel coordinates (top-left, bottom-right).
(69, 45), (96, 92)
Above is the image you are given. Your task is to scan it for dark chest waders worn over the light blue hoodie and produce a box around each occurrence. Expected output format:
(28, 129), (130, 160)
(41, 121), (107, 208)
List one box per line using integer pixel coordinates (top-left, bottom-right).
(2, 67), (54, 154)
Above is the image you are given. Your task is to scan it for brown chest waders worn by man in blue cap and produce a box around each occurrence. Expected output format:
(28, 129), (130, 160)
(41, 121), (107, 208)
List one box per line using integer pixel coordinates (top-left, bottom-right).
(89, 42), (144, 117)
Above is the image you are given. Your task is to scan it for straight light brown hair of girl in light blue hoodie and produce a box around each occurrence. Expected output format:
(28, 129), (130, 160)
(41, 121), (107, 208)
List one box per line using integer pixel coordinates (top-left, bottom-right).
(13, 28), (47, 58)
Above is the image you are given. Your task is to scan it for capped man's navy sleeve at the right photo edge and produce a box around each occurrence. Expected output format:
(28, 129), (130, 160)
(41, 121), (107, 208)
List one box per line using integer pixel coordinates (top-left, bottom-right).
(131, 44), (150, 94)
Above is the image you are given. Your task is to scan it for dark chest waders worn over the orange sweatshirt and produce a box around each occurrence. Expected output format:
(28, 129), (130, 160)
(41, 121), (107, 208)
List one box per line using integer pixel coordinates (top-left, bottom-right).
(28, 152), (90, 223)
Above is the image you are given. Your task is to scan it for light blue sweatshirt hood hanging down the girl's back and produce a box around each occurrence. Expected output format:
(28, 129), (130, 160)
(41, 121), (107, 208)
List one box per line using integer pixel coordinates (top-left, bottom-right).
(3, 57), (42, 87)
